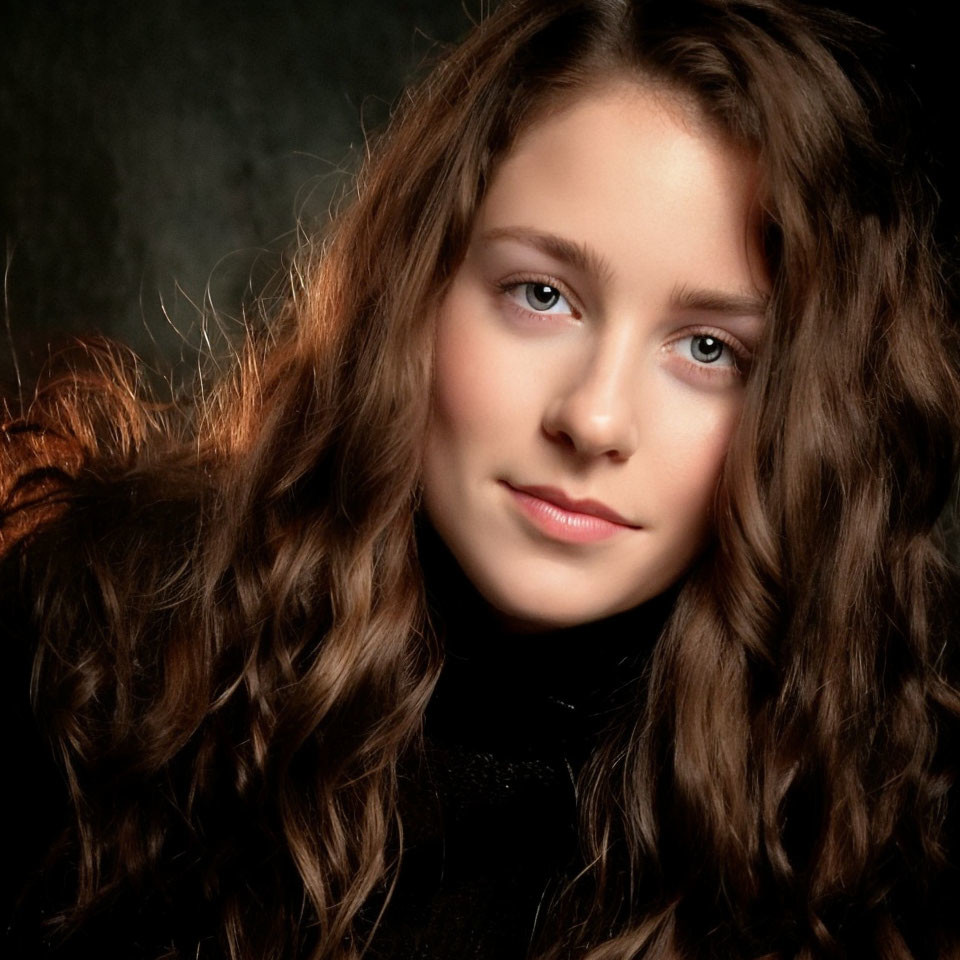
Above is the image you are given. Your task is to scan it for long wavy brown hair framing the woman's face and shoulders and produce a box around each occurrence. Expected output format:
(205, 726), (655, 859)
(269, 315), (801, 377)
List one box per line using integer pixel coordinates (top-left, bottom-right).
(0, 0), (960, 960)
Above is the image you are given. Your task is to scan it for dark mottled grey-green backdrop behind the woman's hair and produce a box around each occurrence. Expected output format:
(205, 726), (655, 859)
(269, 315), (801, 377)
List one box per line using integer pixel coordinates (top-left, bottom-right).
(0, 0), (957, 386)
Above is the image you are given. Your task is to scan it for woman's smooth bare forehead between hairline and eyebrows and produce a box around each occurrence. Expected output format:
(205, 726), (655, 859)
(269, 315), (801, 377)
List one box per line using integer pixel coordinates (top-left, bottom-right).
(475, 81), (764, 298)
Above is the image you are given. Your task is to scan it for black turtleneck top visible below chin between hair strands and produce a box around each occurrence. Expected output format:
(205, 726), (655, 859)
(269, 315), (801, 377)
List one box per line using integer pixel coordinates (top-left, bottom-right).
(362, 530), (672, 960)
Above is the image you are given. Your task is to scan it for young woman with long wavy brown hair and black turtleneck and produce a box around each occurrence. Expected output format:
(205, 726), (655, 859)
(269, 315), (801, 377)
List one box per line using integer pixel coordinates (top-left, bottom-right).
(2, 0), (960, 960)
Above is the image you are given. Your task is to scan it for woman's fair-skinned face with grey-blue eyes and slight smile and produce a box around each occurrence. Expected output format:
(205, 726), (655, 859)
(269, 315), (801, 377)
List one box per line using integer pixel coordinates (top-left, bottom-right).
(424, 82), (766, 630)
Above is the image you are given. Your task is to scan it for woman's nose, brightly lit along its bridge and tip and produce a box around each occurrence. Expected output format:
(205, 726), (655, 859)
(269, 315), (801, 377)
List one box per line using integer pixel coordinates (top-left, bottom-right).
(542, 344), (640, 460)
